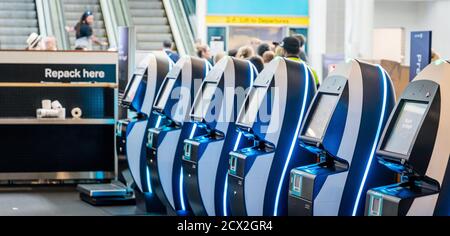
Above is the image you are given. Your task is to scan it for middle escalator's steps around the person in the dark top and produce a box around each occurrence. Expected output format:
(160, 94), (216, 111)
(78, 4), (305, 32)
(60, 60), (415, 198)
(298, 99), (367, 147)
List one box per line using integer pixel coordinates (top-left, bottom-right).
(63, 0), (108, 50)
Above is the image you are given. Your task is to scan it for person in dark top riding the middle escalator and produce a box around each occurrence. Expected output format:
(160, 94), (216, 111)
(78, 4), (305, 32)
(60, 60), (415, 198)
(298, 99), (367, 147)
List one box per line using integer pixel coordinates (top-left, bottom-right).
(66, 11), (108, 50)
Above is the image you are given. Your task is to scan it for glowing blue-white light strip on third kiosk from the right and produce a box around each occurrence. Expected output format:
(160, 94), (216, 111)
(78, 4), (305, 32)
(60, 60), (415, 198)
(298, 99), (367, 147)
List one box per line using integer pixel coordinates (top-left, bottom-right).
(273, 63), (310, 216)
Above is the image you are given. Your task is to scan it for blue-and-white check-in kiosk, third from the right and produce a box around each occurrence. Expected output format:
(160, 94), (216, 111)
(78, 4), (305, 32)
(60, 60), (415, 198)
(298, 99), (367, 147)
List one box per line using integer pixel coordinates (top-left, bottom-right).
(227, 58), (316, 216)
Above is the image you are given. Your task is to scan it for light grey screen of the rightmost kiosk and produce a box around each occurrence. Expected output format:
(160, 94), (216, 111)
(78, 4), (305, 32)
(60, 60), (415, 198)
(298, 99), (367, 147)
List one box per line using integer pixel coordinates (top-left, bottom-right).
(384, 102), (428, 155)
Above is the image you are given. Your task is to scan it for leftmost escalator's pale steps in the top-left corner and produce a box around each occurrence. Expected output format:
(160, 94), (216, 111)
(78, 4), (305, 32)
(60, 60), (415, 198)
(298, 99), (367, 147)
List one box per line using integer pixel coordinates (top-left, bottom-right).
(0, 0), (39, 49)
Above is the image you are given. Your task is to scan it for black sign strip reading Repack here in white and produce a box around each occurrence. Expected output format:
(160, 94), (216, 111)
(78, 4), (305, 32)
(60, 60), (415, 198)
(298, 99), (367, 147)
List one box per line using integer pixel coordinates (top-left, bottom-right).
(0, 64), (117, 83)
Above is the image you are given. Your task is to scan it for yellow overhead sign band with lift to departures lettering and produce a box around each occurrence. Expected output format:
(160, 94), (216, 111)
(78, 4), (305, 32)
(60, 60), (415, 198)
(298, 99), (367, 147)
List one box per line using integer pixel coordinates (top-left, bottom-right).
(206, 16), (309, 26)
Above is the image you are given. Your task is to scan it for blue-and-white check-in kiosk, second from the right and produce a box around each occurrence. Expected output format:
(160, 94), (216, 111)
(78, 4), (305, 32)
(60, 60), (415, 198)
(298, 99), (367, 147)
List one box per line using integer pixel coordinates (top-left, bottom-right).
(288, 60), (395, 216)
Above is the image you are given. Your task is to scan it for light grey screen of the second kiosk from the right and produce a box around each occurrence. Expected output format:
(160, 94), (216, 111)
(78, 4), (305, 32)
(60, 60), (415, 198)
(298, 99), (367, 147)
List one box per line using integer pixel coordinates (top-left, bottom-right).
(305, 94), (339, 139)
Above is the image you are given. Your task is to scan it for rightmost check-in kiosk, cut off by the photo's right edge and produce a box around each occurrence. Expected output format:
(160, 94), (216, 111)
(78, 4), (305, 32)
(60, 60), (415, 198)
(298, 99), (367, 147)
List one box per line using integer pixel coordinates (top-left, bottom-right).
(366, 61), (450, 216)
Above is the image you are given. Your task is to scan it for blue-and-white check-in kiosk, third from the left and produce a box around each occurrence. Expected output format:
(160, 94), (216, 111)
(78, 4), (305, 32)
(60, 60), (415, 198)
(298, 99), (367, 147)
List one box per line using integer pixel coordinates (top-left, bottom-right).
(182, 57), (257, 216)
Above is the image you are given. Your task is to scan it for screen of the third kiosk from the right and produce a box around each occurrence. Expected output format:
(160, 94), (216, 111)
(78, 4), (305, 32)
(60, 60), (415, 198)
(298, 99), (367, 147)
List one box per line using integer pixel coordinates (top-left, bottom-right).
(238, 87), (267, 127)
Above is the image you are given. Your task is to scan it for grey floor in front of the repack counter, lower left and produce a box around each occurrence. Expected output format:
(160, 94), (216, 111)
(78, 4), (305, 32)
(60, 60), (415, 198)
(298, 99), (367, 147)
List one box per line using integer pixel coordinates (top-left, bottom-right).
(0, 187), (144, 216)
